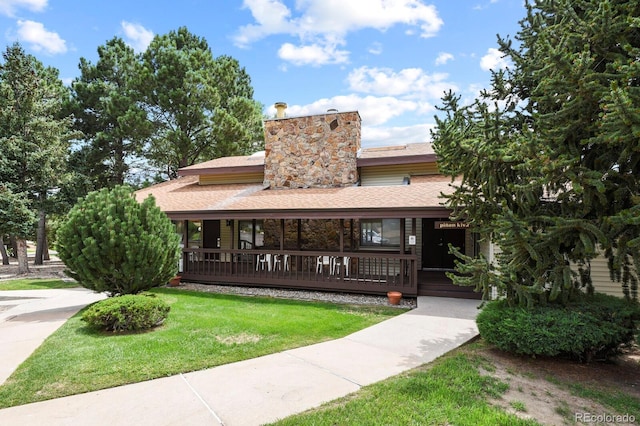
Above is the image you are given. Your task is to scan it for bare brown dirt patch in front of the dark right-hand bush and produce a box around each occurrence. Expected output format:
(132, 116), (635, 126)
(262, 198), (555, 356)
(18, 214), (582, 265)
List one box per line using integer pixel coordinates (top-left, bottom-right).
(482, 348), (640, 425)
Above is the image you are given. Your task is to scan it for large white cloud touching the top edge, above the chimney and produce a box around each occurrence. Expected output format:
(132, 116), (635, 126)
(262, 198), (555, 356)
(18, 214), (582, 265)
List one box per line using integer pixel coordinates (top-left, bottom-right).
(234, 0), (443, 64)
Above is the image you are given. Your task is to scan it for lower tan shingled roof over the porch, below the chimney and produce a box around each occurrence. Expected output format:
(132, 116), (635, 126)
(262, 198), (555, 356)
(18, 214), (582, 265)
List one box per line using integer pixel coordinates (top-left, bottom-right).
(136, 175), (452, 219)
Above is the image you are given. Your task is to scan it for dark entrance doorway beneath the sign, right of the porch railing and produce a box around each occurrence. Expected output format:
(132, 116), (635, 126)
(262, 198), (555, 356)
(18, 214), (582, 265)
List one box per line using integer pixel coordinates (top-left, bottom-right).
(422, 218), (465, 269)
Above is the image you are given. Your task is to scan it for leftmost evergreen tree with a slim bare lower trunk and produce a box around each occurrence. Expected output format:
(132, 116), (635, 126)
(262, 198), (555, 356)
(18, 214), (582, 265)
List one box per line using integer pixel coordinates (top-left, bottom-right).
(0, 44), (72, 264)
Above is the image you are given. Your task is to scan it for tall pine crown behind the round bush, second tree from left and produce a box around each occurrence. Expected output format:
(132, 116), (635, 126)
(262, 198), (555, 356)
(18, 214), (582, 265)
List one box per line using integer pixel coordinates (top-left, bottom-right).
(70, 37), (151, 188)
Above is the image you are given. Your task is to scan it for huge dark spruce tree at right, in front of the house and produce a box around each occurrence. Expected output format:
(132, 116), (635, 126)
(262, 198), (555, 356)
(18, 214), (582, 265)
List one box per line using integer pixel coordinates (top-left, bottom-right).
(433, 0), (640, 305)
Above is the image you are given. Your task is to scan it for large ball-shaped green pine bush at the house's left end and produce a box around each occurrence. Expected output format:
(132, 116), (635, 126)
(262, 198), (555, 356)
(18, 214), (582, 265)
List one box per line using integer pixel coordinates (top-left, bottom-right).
(57, 186), (180, 296)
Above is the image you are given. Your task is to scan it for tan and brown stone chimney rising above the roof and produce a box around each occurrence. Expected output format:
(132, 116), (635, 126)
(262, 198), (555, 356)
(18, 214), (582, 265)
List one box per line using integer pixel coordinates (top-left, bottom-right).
(264, 102), (361, 189)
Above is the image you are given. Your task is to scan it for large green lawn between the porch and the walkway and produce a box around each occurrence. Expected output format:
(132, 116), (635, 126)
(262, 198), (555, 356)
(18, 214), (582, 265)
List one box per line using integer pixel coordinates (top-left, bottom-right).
(0, 288), (402, 408)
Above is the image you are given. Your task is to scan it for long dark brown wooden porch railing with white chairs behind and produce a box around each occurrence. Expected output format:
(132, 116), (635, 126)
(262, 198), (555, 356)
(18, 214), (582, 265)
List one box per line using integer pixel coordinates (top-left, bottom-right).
(181, 248), (417, 296)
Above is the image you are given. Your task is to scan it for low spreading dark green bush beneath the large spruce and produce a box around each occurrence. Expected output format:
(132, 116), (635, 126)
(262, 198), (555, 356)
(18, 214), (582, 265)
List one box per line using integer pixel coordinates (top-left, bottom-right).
(476, 294), (640, 361)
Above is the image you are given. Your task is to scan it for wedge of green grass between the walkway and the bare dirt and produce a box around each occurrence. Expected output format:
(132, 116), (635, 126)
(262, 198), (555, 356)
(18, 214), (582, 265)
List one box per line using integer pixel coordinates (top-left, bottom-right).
(274, 349), (538, 426)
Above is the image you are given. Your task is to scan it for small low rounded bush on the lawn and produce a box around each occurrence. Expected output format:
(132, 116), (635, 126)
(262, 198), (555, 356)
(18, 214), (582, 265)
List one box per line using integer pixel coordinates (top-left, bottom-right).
(82, 294), (170, 332)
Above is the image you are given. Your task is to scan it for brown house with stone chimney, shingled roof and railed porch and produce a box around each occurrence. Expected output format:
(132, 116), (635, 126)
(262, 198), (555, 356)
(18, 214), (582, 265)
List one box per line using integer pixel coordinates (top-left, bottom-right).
(136, 104), (628, 298)
